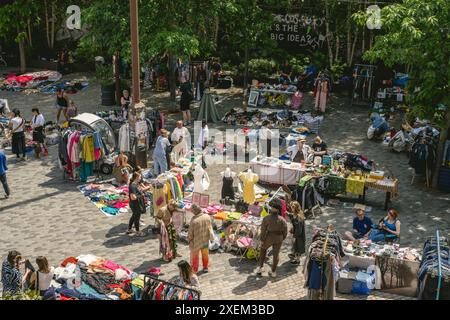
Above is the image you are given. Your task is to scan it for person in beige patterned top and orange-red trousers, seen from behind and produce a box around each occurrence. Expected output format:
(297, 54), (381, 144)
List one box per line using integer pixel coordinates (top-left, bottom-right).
(188, 204), (212, 273)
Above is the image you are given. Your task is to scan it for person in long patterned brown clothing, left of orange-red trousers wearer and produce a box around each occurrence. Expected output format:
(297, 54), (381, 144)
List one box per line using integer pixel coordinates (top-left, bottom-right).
(155, 200), (181, 262)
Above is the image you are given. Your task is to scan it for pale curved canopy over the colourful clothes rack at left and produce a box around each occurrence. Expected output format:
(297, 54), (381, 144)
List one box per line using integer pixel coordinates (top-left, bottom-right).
(69, 112), (117, 153)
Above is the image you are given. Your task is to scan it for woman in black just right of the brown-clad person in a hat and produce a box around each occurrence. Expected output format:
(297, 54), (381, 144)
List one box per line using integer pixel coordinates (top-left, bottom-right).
(288, 201), (306, 264)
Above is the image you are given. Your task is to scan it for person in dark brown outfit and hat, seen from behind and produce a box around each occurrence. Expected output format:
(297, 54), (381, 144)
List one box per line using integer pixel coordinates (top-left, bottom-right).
(256, 199), (288, 278)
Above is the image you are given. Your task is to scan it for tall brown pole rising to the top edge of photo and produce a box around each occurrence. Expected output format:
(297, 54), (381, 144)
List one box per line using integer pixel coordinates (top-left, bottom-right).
(128, 0), (147, 168)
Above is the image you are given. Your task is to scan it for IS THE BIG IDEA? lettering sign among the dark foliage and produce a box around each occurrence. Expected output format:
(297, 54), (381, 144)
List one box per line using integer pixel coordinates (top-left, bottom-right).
(270, 13), (326, 51)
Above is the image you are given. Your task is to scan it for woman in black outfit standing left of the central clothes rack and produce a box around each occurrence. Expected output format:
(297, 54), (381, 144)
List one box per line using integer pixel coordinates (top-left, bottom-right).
(127, 172), (150, 236)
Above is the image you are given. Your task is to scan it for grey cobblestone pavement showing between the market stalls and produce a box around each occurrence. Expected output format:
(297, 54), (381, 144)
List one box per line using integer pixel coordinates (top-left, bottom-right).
(0, 70), (450, 300)
